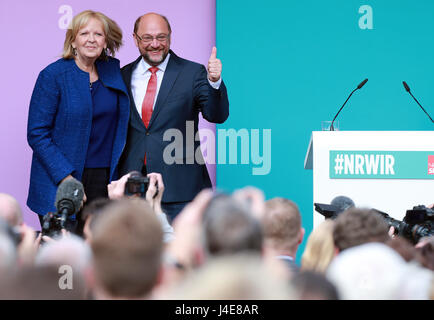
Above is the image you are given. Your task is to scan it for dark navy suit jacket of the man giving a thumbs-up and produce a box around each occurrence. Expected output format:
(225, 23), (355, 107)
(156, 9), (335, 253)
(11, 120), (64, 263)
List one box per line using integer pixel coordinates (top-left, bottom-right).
(120, 51), (229, 202)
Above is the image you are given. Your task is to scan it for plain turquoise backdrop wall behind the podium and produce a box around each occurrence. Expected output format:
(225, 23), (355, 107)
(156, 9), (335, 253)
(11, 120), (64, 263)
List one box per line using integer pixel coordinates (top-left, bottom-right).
(217, 0), (434, 261)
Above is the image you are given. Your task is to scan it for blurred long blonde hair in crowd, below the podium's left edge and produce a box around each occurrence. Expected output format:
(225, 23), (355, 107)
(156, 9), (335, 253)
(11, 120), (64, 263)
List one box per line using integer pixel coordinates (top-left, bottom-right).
(301, 219), (336, 273)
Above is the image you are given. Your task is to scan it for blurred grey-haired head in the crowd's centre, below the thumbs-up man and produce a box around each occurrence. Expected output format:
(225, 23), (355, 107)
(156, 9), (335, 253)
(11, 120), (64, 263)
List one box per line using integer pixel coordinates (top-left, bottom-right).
(203, 195), (263, 256)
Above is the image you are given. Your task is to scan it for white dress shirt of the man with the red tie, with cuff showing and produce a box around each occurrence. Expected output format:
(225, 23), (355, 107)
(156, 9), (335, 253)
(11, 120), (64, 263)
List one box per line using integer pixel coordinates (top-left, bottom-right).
(131, 53), (222, 118)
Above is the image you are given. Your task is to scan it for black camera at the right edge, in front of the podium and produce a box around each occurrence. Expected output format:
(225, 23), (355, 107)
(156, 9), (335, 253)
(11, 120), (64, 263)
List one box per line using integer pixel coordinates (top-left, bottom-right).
(372, 205), (434, 244)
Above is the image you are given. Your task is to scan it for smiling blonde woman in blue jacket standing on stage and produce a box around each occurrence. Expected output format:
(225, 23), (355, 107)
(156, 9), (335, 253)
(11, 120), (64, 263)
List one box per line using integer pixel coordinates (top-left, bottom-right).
(27, 10), (129, 232)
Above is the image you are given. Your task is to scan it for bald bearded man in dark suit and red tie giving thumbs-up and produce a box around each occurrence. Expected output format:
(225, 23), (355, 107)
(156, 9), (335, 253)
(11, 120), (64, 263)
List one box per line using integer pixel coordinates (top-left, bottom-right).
(120, 13), (229, 220)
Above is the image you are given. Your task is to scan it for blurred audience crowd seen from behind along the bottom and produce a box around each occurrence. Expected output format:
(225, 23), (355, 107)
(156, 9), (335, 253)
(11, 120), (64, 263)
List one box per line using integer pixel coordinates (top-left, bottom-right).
(0, 173), (434, 300)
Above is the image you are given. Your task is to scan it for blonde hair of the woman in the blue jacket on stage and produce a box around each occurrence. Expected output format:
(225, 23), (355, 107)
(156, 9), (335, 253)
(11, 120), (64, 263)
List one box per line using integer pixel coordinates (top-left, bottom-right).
(62, 10), (122, 59)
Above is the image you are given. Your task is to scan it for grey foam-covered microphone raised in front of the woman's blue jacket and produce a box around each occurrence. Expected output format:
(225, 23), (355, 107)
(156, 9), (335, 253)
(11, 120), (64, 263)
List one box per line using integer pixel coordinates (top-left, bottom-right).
(54, 178), (84, 228)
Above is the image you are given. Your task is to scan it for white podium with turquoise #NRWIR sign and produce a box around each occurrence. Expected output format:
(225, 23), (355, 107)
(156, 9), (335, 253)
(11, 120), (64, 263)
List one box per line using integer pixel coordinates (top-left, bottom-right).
(304, 131), (434, 228)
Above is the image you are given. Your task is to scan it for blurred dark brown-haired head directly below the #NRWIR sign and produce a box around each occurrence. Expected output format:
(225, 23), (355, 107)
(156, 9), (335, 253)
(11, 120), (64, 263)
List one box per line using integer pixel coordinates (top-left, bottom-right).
(333, 208), (389, 252)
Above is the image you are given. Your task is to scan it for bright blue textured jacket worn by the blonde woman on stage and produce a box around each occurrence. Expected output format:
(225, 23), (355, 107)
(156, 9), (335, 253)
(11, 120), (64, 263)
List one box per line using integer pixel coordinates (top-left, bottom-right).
(27, 58), (129, 215)
